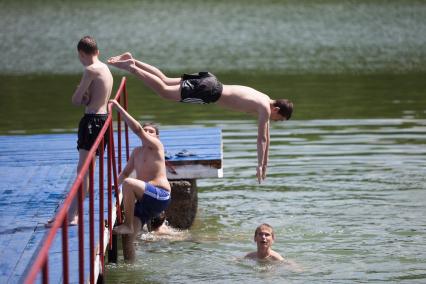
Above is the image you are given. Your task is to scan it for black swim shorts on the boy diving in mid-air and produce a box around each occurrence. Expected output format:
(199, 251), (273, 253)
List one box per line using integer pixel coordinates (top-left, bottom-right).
(180, 72), (223, 104)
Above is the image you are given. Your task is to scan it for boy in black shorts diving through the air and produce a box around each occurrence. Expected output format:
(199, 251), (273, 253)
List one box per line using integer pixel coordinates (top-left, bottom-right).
(108, 52), (293, 183)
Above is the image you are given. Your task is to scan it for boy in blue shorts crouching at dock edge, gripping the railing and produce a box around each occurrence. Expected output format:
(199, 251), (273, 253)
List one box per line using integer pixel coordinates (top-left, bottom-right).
(111, 100), (171, 235)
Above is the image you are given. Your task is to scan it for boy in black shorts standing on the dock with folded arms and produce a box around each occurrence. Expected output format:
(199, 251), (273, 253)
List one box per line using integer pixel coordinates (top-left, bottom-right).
(70, 36), (113, 224)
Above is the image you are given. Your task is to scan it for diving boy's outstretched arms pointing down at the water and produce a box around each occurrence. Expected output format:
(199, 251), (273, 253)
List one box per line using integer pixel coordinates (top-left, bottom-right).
(256, 113), (269, 183)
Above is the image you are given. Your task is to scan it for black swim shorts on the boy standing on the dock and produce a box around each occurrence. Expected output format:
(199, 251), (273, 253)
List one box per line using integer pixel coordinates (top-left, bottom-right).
(77, 113), (109, 155)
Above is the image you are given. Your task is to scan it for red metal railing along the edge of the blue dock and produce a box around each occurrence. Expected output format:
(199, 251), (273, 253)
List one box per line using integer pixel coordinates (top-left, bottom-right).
(25, 77), (129, 284)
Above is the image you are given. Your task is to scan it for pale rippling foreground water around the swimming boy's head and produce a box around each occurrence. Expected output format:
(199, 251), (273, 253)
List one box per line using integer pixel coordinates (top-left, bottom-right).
(107, 119), (426, 283)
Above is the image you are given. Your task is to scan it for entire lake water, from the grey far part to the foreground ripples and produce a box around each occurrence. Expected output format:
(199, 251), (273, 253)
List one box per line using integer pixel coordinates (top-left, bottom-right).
(0, 0), (426, 283)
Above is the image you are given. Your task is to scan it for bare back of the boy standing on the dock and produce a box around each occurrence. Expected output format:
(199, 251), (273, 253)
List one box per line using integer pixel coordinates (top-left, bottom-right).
(85, 61), (113, 113)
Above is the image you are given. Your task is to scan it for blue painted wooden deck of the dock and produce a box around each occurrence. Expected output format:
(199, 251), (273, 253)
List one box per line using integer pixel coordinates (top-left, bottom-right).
(0, 128), (222, 283)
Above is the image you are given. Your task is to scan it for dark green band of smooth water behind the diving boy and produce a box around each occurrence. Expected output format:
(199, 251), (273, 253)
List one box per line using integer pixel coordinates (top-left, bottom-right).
(0, 72), (426, 134)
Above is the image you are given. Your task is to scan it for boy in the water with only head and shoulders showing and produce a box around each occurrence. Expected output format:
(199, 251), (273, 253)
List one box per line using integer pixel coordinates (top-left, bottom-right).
(245, 223), (284, 261)
